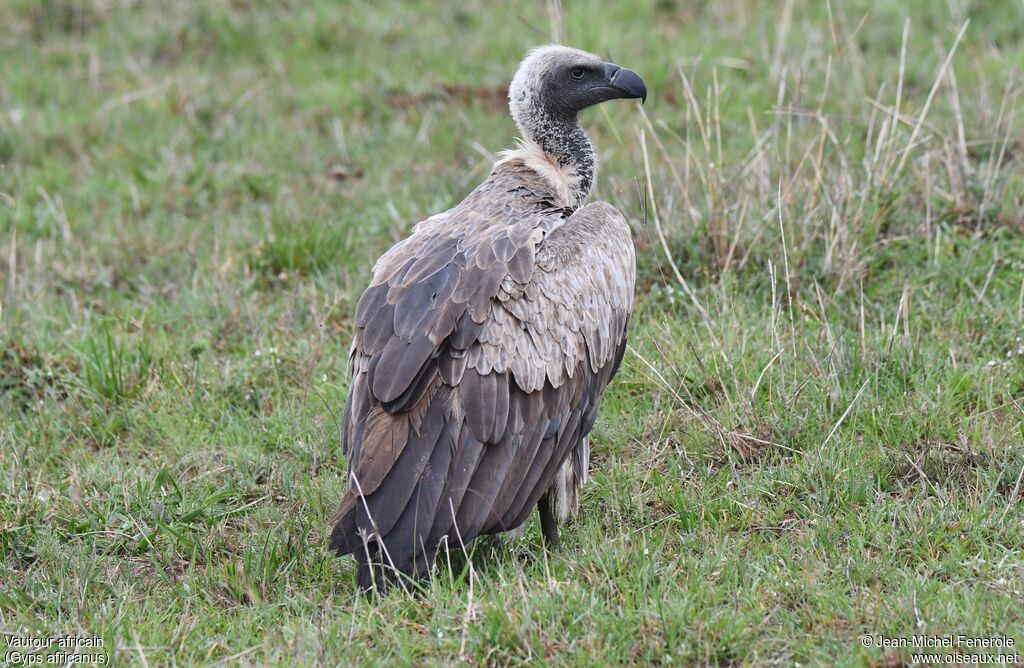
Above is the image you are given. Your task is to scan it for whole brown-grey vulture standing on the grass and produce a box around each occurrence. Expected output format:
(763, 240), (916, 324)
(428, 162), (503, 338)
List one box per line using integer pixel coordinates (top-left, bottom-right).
(331, 45), (647, 591)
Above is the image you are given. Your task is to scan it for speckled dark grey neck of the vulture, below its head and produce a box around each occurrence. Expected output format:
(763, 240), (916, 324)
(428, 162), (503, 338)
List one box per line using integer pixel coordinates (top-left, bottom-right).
(519, 114), (597, 209)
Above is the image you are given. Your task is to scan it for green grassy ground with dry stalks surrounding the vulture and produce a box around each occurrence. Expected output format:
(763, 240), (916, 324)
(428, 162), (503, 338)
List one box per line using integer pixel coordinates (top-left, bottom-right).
(0, 0), (1024, 666)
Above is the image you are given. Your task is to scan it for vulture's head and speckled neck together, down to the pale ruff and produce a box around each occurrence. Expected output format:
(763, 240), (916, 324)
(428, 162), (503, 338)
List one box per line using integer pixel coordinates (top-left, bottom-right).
(509, 44), (647, 207)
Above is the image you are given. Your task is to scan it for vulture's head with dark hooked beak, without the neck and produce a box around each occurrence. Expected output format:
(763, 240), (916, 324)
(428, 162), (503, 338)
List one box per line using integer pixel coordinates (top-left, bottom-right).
(509, 45), (647, 132)
